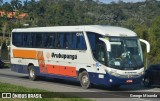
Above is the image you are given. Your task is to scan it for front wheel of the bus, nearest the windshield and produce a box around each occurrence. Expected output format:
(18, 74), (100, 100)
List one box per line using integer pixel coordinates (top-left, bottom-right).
(79, 71), (91, 89)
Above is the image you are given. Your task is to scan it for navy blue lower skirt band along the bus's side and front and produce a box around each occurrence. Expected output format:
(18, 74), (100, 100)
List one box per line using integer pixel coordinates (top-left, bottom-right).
(11, 64), (143, 87)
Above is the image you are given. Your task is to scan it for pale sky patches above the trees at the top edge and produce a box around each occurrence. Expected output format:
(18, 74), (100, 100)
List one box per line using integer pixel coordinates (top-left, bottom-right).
(3, 0), (148, 3)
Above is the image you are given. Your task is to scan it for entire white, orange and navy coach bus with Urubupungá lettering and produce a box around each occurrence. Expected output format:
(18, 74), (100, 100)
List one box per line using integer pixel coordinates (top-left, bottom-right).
(10, 25), (150, 88)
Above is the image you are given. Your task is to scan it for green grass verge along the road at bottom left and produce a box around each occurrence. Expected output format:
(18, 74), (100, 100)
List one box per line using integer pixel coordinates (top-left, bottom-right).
(0, 83), (91, 101)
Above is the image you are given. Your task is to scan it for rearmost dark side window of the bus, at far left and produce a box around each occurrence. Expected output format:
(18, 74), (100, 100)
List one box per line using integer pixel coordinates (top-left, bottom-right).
(12, 33), (21, 47)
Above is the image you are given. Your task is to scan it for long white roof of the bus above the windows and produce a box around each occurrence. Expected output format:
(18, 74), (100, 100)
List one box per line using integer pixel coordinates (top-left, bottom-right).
(12, 25), (137, 37)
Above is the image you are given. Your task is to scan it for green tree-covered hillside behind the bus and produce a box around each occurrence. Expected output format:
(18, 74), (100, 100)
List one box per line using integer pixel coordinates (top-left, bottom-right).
(0, 0), (160, 64)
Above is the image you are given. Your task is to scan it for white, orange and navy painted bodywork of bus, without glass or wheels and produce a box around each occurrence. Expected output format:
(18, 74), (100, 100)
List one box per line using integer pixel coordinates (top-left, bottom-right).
(10, 26), (143, 86)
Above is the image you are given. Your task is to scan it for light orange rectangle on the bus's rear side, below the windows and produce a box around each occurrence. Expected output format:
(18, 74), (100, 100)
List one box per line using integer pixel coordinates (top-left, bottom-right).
(13, 49), (37, 59)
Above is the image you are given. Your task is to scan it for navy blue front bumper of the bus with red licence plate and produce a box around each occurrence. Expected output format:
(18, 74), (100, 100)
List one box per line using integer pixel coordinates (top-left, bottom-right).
(89, 73), (143, 86)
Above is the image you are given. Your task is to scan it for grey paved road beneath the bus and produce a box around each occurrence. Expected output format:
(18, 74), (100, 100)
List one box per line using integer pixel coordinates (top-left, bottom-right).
(0, 69), (160, 101)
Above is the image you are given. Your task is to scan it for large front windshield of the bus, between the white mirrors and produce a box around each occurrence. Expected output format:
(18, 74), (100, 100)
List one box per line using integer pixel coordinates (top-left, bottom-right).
(108, 38), (143, 70)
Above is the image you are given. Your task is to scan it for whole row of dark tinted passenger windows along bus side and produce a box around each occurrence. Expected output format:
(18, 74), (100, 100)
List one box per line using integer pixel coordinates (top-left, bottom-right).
(12, 32), (87, 50)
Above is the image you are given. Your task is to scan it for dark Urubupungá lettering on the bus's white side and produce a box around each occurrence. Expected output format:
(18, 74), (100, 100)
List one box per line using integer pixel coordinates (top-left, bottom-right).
(52, 53), (77, 60)
